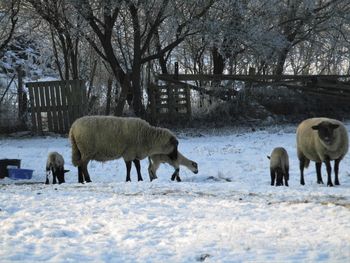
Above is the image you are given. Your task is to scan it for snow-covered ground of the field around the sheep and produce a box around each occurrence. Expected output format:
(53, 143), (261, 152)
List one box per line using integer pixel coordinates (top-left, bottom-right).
(0, 126), (350, 262)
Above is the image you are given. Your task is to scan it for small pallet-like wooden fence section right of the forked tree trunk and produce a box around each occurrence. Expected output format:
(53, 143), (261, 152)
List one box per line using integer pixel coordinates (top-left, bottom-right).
(149, 84), (191, 121)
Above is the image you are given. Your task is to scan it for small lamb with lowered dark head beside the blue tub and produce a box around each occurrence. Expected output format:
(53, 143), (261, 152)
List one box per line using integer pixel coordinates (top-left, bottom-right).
(45, 152), (69, 184)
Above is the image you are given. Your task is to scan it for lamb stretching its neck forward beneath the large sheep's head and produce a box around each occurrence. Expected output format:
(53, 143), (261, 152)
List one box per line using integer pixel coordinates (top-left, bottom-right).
(148, 152), (198, 182)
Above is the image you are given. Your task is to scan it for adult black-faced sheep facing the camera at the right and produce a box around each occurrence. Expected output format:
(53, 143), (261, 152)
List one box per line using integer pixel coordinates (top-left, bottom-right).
(297, 118), (349, 186)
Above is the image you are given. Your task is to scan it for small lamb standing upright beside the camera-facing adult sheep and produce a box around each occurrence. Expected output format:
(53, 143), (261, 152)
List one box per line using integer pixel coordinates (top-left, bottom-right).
(267, 147), (289, 186)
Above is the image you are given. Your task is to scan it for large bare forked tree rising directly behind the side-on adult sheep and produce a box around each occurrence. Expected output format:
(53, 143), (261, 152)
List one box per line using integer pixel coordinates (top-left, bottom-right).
(73, 0), (214, 116)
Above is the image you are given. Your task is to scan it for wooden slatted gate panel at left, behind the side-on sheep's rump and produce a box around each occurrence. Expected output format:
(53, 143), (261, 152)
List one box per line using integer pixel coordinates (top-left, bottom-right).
(26, 80), (86, 134)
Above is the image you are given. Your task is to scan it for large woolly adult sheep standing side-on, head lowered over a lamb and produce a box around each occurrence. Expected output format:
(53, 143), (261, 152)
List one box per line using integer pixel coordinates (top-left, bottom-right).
(69, 116), (178, 183)
